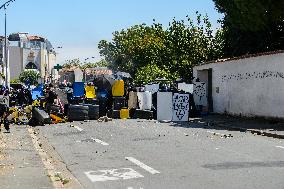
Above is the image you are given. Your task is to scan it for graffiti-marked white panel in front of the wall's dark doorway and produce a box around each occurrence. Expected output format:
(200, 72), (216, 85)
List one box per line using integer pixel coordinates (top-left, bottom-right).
(193, 82), (207, 106)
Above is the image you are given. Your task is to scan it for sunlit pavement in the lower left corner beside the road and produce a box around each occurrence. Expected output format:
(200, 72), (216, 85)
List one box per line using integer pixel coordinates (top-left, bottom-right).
(0, 125), (53, 189)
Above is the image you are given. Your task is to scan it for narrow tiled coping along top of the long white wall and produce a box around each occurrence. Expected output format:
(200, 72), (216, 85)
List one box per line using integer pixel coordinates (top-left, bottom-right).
(197, 50), (284, 66)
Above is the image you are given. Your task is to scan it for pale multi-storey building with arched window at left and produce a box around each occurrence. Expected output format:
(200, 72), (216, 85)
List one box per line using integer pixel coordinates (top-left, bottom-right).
(8, 33), (56, 82)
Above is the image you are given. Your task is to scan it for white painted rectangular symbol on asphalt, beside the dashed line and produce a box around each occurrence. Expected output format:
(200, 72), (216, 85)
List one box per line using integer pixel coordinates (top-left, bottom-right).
(85, 168), (144, 182)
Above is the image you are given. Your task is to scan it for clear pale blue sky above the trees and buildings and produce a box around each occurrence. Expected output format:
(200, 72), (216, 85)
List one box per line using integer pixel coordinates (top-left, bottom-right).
(0, 0), (222, 64)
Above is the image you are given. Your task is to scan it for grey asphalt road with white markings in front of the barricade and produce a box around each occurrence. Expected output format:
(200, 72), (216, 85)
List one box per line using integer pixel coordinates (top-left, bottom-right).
(39, 120), (284, 189)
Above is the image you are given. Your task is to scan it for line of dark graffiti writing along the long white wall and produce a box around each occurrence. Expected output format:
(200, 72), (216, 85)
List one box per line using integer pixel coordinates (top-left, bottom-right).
(222, 71), (284, 82)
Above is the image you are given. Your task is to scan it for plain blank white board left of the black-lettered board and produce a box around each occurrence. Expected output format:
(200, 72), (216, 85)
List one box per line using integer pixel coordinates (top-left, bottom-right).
(157, 92), (173, 121)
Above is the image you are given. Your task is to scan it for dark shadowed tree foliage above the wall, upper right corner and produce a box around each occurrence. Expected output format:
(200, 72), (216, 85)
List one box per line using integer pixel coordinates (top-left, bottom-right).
(213, 0), (284, 57)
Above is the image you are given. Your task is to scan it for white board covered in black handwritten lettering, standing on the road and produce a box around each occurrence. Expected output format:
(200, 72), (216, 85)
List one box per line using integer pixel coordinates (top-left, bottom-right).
(173, 93), (189, 121)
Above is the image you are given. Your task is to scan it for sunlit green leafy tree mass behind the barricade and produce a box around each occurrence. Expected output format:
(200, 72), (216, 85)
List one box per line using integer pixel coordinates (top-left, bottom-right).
(98, 13), (223, 83)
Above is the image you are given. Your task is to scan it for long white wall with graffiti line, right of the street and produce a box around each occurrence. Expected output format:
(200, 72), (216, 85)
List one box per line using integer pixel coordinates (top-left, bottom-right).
(194, 53), (284, 118)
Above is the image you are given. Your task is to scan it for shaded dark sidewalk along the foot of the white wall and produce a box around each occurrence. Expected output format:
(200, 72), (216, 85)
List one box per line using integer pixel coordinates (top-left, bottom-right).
(199, 114), (284, 139)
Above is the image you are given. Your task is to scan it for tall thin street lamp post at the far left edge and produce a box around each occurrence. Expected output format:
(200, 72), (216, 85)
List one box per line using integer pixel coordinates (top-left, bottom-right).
(0, 0), (16, 87)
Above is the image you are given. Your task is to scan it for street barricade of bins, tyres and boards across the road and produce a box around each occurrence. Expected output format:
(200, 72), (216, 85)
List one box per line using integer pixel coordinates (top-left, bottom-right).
(0, 75), (207, 126)
